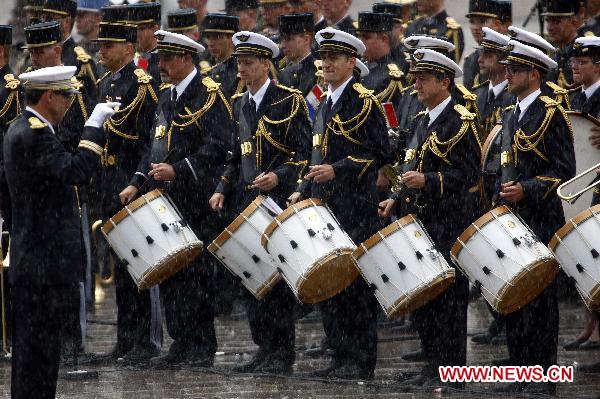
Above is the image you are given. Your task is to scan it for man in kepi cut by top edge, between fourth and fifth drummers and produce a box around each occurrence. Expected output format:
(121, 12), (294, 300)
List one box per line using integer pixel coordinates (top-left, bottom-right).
(463, 0), (512, 90)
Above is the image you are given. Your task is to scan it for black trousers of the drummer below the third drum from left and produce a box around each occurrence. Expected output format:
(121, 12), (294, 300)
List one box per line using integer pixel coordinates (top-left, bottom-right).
(319, 277), (379, 370)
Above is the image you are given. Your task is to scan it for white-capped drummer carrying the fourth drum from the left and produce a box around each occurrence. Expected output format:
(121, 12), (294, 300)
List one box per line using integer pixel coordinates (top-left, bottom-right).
(380, 49), (481, 387)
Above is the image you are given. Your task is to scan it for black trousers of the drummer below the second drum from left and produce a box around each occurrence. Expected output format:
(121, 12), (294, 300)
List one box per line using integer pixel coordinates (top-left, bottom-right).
(245, 281), (297, 362)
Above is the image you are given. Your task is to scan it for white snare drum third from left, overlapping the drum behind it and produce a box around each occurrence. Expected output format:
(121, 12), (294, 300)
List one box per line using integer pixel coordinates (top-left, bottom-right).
(261, 198), (359, 303)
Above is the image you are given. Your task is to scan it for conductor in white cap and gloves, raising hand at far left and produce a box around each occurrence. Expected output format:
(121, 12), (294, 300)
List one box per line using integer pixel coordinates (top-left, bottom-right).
(2, 66), (116, 399)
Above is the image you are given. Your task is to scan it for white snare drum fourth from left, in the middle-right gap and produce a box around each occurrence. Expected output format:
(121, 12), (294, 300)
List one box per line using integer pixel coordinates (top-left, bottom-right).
(352, 215), (455, 318)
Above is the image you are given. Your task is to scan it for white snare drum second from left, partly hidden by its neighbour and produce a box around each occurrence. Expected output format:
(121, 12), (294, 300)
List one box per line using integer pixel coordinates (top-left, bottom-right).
(208, 195), (281, 299)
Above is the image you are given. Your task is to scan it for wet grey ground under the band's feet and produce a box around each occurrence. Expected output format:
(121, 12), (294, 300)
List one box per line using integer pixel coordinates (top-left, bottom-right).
(0, 286), (600, 399)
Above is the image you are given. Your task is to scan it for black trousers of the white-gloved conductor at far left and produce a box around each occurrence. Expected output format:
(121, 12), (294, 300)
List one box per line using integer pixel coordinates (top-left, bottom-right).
(11, 284), (79, 399)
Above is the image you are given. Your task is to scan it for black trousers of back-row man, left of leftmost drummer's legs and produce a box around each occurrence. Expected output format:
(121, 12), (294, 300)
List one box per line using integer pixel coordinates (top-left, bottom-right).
(115, 257), (155, 352)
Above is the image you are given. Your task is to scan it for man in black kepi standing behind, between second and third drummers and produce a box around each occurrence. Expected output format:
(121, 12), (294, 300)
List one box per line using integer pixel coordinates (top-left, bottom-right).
(279, 13), (321, 98)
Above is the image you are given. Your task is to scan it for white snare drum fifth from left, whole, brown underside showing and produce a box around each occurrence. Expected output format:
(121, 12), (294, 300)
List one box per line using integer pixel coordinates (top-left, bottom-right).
(450, 206), (559, 314)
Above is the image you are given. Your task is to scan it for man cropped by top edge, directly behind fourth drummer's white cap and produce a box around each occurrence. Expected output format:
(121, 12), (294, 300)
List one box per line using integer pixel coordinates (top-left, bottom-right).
(406, 0), (465, 63)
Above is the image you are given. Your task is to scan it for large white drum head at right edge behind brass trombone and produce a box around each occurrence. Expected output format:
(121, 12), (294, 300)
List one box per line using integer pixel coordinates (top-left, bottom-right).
(563, 111), (600, 219)
